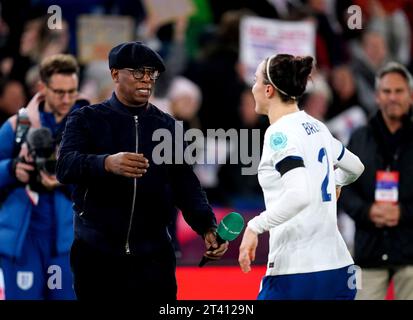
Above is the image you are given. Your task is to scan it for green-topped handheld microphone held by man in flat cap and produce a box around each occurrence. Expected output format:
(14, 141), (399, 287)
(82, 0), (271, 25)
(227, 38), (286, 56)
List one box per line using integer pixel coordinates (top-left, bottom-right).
(198, 212), (244, 267)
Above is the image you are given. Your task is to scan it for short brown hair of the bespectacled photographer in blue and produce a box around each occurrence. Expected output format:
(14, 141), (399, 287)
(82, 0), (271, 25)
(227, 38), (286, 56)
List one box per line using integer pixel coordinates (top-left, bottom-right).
(40, 54), (79, 83)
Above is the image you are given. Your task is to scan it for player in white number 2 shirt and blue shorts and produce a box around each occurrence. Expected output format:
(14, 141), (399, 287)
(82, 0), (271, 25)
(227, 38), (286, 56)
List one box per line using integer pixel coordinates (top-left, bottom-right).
(238, 54), (364, 300)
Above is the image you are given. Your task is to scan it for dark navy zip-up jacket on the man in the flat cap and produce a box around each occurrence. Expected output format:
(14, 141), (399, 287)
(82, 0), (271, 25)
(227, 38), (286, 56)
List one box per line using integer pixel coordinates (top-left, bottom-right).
(57, 94), (216, 255)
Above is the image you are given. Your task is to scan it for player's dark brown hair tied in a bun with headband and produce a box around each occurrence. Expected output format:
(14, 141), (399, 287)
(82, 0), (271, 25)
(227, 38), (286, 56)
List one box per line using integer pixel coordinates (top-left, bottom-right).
(263, 54), (314, 102)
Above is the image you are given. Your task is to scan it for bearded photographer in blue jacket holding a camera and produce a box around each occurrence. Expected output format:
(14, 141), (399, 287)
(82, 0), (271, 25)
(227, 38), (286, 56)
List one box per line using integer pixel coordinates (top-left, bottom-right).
(0, 54), (88, 300)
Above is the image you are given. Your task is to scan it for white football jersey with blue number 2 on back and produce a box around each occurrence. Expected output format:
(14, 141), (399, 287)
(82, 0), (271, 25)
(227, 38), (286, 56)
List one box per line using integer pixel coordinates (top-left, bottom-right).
(258, 111), (354, 275)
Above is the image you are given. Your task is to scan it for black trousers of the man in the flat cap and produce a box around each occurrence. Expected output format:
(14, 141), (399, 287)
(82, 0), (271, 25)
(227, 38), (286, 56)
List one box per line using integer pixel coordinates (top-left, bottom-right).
(70, 239), (177, 302)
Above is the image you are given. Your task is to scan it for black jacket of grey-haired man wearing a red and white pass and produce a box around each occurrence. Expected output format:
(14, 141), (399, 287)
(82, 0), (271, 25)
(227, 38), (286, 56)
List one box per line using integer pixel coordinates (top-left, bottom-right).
(339, 111), (413, 267)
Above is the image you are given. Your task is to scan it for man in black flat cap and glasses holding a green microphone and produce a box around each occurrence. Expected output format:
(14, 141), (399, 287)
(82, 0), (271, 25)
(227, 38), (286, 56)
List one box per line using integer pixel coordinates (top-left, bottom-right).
(57, 42), (228, 301)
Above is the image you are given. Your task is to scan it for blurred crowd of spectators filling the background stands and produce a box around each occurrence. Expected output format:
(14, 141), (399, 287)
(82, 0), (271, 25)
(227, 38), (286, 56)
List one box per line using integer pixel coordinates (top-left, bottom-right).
(0, 0), (413, 208)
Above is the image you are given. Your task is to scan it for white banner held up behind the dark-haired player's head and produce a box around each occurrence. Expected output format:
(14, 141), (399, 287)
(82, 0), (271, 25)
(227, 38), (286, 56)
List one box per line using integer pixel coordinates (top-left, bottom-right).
(240, 17), (315, 85)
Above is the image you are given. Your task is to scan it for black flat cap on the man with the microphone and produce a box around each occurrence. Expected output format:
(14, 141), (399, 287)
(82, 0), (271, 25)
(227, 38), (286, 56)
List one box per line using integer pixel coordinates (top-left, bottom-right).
(109, 41), (165, 72)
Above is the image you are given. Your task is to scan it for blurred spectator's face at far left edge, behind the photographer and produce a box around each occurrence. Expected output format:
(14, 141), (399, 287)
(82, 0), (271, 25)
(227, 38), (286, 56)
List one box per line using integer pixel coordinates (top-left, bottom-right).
(0, 79), (26, 127)
